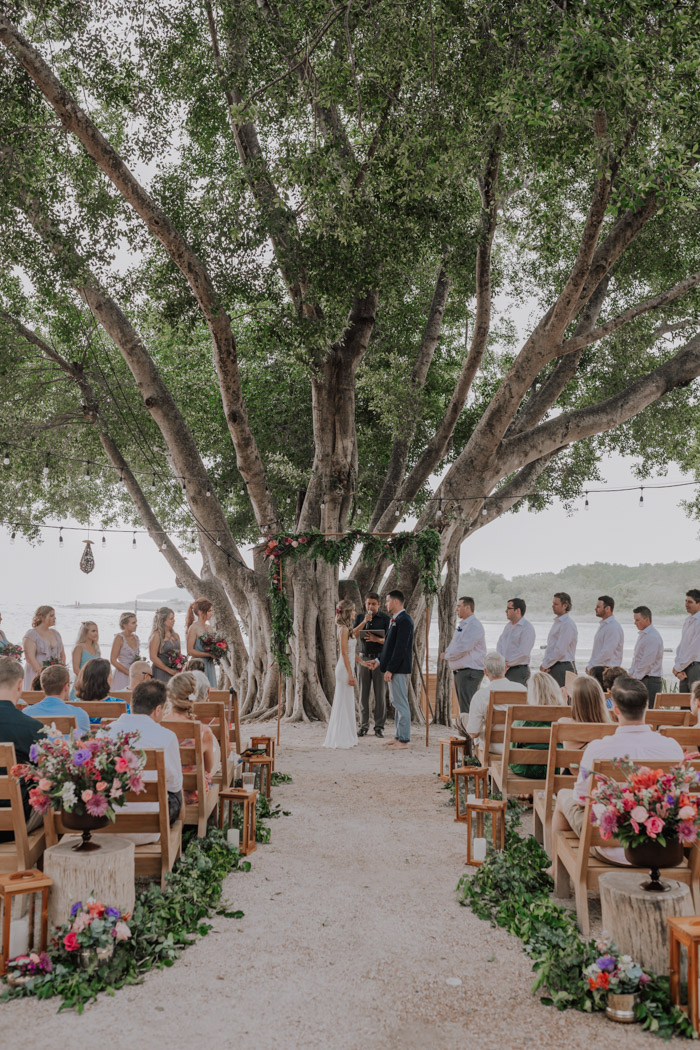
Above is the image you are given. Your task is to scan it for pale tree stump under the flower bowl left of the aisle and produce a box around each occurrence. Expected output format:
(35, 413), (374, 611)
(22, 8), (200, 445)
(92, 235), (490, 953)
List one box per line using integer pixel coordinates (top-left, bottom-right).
(44, 835), (135, 926)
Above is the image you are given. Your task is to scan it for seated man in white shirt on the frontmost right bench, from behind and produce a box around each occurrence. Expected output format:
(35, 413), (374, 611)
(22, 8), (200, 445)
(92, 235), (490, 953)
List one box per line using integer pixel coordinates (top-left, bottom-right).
(552, 675), (683, 839)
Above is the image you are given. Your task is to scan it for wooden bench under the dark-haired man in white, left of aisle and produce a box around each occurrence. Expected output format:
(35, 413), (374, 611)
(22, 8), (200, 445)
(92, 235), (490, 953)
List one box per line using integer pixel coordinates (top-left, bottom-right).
(44, 749), (183, 888)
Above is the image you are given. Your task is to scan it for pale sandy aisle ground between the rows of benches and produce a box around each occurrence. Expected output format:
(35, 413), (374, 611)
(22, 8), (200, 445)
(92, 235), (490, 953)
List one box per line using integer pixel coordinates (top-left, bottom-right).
(0, 726), (675, 1050)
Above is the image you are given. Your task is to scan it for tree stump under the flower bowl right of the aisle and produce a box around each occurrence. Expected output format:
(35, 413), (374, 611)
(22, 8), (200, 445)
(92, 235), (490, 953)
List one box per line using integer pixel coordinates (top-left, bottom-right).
(599, 872), (695, 973)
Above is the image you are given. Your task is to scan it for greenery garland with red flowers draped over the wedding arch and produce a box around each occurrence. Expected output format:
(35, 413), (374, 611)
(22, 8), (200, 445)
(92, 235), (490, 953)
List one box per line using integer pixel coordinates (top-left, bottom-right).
(262, 528), (441, 677)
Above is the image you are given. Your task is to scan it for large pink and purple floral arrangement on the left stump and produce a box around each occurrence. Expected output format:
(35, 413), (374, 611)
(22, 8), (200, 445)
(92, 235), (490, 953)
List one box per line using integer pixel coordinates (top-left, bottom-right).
(10, 728), (146, 820)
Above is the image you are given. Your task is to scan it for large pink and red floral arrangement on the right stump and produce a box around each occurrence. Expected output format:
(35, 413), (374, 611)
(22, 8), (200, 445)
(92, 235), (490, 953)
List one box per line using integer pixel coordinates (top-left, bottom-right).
(591, 761), (700, 846)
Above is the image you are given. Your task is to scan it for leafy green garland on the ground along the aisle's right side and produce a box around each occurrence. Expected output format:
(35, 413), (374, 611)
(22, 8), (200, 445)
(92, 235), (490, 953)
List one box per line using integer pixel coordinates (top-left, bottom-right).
(457, 823), (697, 1040)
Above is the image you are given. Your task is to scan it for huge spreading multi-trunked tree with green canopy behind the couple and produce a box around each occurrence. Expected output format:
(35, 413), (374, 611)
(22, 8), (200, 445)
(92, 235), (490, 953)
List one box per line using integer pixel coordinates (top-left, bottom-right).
(0, 0), (700, 718)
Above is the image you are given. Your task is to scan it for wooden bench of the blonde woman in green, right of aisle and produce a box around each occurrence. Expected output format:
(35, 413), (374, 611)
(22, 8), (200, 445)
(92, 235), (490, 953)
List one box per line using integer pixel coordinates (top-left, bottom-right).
(489, 704), (571, 801)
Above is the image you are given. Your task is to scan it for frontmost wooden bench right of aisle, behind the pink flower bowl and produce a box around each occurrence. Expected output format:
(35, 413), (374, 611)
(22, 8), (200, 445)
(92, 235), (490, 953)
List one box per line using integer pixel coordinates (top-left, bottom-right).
(553, 758), (700, 937)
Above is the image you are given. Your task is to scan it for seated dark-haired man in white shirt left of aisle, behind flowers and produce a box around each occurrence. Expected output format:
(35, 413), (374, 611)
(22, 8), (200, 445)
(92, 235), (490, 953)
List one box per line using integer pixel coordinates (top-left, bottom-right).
(107, 679), (183, 824)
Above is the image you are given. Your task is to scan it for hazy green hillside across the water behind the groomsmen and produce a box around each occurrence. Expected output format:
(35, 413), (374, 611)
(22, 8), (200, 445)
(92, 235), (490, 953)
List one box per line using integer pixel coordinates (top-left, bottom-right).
(459, 561), (700, 620)
